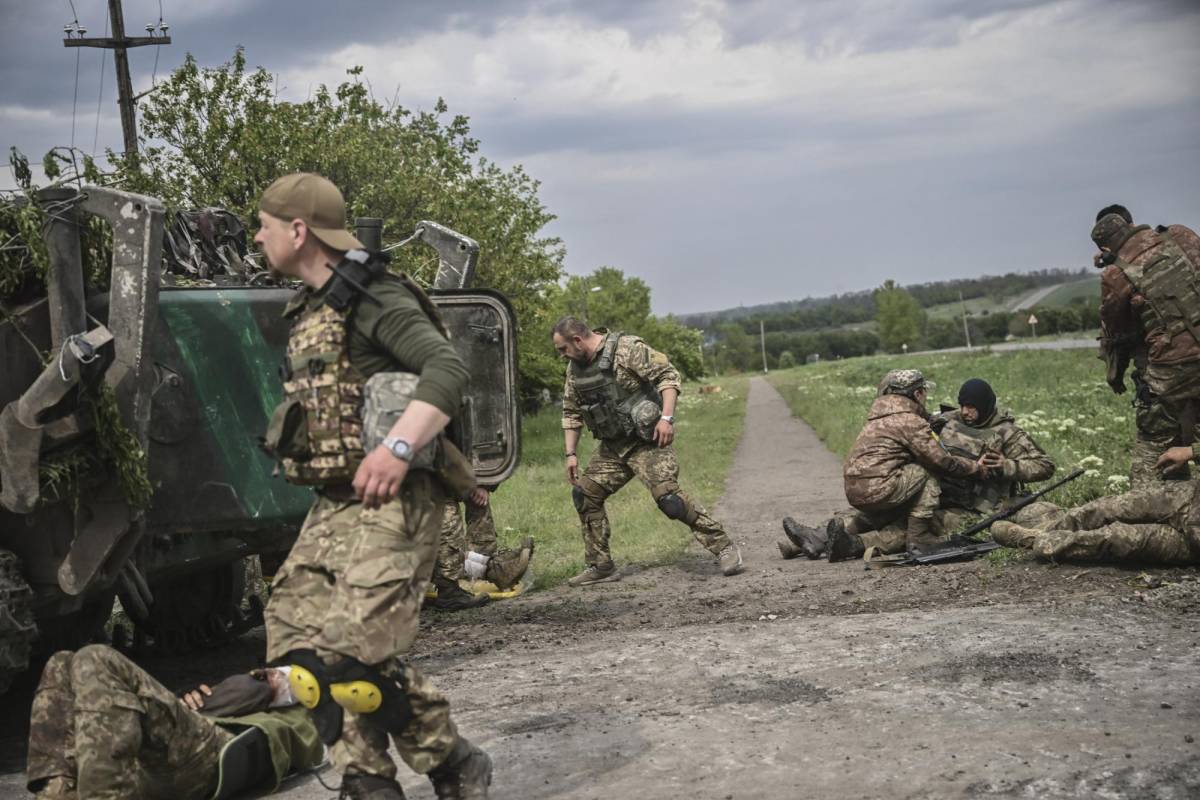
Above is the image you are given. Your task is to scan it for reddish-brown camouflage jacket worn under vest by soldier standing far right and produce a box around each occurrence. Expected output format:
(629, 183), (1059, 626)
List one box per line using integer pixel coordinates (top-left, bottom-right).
(1100, 225), (1200, 383)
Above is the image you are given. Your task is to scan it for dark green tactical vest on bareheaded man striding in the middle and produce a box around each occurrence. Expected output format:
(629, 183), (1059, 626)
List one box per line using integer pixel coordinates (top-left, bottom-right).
(568, 331), (662, 441)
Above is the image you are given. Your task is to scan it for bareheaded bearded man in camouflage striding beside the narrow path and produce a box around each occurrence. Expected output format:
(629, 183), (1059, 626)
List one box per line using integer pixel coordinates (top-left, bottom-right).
(552, 317), (742, 587)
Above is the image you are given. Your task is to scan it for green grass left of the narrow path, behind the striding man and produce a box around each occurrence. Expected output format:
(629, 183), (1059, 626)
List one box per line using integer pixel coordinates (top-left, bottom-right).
(493, 378), (748, 589)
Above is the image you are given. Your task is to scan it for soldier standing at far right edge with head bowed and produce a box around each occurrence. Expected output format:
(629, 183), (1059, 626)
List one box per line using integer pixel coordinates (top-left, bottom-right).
(1092, 205), (1200, 489)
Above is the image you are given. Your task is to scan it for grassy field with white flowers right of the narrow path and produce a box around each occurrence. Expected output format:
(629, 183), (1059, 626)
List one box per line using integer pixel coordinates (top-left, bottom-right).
(770, 349), (1134, 506)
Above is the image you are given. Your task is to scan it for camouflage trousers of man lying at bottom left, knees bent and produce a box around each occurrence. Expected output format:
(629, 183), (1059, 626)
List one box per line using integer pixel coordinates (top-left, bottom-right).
(25, 644), (233, 800)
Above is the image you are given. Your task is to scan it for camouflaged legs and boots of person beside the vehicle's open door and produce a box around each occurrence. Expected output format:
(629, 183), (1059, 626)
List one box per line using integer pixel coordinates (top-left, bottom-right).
(430, 487), (533, 612)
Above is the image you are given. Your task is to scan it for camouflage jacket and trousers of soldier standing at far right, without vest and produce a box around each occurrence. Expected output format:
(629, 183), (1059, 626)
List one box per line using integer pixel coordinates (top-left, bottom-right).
(1093, 217), (1200, 489)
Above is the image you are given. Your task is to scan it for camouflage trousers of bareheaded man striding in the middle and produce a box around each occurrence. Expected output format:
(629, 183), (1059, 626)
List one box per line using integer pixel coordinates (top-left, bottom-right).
(571, 441), (730, 570)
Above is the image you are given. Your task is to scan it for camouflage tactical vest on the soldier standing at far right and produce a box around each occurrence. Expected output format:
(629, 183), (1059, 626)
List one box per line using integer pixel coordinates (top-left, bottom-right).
(1116, 231), (1200, 352)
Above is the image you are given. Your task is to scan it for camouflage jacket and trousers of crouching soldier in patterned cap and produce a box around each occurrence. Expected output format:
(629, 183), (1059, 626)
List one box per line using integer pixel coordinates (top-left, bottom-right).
(842, 393), (978, 553)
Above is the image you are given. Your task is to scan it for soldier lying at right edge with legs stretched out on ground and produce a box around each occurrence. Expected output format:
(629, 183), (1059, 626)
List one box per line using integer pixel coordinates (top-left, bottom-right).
(991, 445), (1200, 566)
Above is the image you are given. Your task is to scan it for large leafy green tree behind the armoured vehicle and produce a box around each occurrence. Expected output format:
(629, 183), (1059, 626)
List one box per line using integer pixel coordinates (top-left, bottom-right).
(110, 48), (563, 396)
